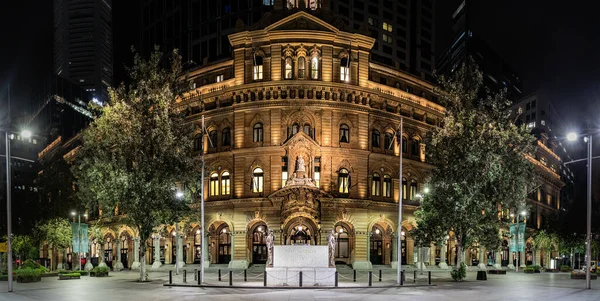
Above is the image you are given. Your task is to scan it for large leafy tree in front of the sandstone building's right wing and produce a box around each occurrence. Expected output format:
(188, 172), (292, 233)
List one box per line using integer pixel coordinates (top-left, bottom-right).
(416, 61), (537, 278)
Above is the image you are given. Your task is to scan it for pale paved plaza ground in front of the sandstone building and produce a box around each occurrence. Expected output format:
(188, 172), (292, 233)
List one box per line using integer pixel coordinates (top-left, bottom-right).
(0, 270), (600, 301)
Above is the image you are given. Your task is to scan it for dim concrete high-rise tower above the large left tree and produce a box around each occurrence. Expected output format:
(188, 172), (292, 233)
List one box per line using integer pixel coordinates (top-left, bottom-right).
(54, 0), (113, 102)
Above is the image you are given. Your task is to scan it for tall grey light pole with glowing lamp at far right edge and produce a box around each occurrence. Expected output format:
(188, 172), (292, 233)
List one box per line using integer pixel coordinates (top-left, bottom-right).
(565, 133), (592, 289)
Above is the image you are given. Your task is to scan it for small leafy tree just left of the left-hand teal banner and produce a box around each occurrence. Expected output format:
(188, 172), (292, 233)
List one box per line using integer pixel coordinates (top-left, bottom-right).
(35, 218), (73, 264)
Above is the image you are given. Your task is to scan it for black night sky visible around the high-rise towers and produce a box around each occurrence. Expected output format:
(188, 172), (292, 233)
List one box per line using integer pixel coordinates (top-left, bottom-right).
(0, 0), (600, 230)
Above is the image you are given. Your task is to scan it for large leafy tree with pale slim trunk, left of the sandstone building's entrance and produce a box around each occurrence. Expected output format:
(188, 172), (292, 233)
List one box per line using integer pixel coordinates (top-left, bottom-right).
(73, 50), (197, 281)
